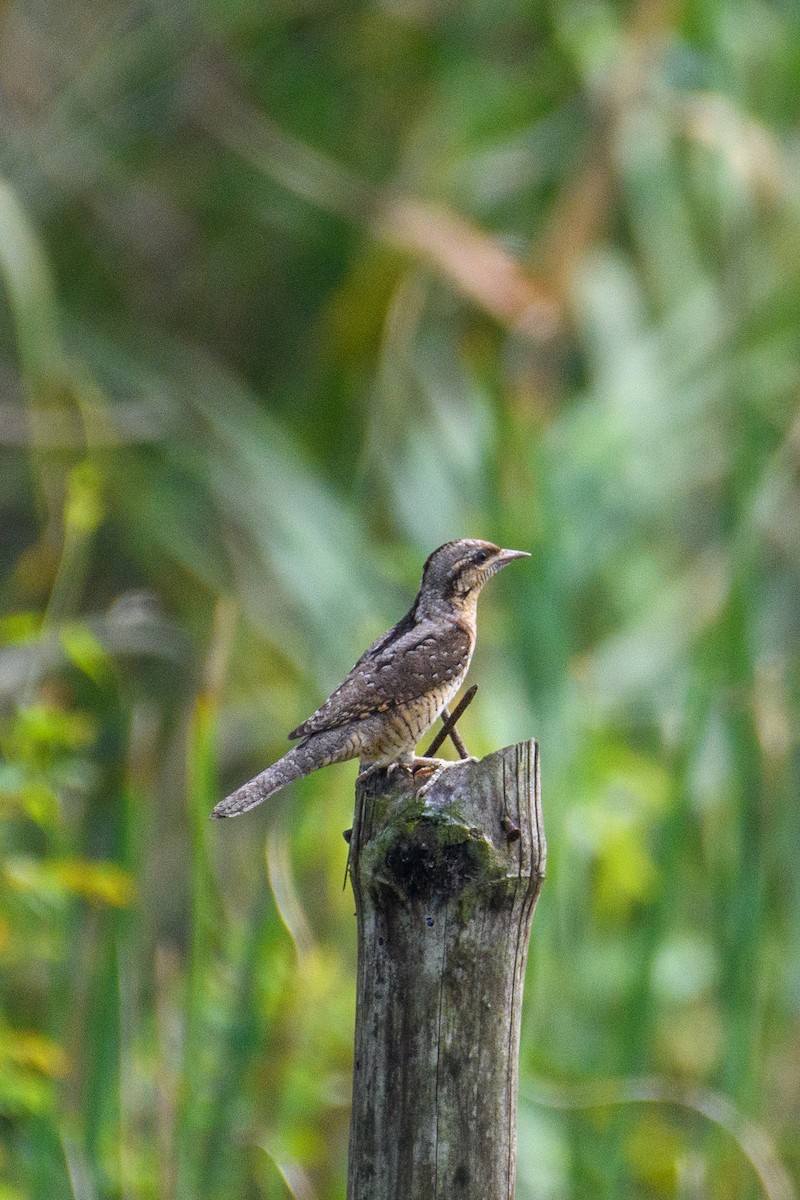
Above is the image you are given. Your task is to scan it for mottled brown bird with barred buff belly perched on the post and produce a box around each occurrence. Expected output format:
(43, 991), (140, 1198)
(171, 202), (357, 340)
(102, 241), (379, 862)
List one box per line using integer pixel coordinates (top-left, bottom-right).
(211, 538), (530, 820)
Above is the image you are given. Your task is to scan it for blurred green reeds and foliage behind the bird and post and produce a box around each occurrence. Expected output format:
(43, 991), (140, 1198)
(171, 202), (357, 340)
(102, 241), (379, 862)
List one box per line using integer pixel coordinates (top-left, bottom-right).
(0, 0), (800, 1200)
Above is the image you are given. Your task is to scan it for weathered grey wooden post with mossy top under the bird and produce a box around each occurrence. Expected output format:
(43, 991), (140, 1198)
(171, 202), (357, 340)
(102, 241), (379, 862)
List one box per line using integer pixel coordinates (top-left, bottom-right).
(348, 742), (546, 1200)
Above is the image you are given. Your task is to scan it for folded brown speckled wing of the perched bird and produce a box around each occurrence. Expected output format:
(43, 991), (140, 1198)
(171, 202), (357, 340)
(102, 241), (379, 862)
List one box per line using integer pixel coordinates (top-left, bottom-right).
(289, 619), (473, 738)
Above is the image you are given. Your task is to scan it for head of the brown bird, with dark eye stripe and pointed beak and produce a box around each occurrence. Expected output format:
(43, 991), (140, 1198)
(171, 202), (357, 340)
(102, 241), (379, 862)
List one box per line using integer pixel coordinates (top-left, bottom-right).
(417, 538), (530, 616)
